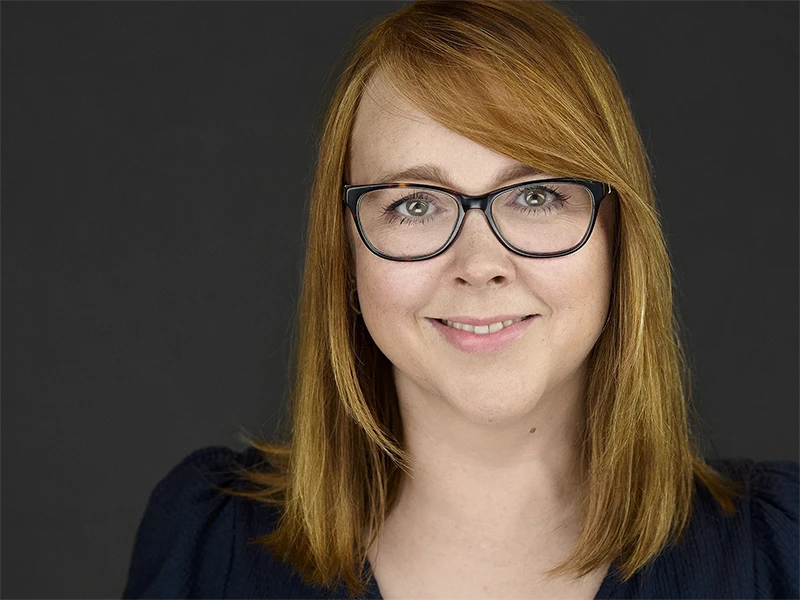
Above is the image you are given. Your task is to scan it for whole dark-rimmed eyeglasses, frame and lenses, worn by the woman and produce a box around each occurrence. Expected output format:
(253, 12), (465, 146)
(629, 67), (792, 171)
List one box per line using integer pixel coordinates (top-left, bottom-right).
(342, 178), (612, 261)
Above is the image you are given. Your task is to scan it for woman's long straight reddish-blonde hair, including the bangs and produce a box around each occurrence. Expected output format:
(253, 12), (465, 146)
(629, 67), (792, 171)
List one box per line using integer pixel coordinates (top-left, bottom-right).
(222, 0), (738, 596)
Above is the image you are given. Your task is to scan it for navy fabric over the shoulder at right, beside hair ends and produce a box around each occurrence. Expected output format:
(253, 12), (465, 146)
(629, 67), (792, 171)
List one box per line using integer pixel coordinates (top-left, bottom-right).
(624, 459), (800, 600)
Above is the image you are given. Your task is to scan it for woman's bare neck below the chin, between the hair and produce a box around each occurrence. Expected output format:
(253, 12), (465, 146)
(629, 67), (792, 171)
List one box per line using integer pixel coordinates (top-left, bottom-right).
(389, 372), (584, 542)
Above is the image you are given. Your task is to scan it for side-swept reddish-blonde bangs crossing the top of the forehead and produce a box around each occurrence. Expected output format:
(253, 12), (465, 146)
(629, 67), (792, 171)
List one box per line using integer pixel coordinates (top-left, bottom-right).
(371, 2), (642, 191)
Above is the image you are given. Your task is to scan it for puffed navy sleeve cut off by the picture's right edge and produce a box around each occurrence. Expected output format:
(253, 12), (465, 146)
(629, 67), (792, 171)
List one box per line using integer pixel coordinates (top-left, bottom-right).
(750, 461), (800, 599)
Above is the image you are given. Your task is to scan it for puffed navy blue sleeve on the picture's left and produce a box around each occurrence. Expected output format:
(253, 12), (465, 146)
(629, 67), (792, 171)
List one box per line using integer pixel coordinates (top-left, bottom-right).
(122, 447), (247, 600)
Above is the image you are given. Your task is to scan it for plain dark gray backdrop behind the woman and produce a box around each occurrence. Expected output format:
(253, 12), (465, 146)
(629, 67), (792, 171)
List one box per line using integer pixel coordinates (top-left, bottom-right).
(0, 0), (800, 599)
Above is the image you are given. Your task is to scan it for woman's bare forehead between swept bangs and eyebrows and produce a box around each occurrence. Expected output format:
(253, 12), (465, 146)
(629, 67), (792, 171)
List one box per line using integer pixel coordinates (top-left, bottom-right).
(348, 74), (520, 189)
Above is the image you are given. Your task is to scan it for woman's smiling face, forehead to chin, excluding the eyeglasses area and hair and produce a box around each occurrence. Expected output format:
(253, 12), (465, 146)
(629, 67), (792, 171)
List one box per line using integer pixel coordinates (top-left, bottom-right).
(347, 77), (614, 423)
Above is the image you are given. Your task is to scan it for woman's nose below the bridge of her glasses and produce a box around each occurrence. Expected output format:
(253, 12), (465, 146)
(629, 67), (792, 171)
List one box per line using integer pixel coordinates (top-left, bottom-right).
(448, 209), (515, 287)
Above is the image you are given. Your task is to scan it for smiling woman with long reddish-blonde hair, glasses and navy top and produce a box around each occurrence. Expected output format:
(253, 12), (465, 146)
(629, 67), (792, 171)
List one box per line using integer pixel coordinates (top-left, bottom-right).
(125, 0), (800, 600)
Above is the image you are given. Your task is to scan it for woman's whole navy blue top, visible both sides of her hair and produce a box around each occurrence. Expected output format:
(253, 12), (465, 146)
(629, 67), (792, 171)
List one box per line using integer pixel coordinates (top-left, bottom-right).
(123, 447), (800, 600)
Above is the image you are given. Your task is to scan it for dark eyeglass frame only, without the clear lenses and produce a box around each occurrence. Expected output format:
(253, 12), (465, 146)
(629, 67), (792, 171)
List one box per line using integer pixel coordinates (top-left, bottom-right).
(342, 177), (613, 262)
